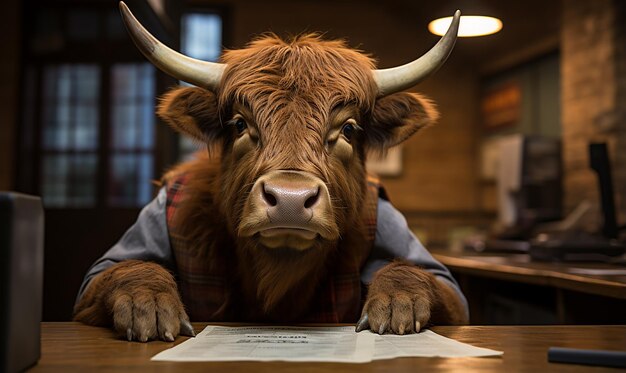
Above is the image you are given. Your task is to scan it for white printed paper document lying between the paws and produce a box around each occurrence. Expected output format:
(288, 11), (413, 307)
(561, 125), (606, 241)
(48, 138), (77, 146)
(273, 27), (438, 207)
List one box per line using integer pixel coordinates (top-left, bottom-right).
(152, 326), (502, 363)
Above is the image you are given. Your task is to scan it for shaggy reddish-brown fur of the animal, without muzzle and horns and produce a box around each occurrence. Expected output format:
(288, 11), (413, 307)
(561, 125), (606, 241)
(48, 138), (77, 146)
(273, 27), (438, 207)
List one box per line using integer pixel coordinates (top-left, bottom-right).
(76, 35), (463, 336)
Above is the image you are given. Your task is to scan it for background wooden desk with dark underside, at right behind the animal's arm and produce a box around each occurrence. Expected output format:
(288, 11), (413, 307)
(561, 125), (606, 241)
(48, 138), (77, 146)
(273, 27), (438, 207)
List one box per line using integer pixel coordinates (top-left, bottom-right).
(432, 250), (626, 324)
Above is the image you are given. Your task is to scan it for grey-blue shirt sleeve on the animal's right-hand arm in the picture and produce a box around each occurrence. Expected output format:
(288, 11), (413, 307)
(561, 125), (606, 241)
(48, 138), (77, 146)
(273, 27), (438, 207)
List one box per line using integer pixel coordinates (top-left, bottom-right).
(361, 198), (469, 315)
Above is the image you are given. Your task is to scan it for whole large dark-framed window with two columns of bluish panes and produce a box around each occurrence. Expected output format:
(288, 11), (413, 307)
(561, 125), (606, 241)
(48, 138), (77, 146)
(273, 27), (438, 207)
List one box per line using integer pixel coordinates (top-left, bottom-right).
(18, 6), (156, 208)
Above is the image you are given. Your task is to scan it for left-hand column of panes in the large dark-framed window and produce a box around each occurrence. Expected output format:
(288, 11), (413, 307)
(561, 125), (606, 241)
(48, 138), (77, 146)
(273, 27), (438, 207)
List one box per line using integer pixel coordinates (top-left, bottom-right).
(41, 64), (100, 207)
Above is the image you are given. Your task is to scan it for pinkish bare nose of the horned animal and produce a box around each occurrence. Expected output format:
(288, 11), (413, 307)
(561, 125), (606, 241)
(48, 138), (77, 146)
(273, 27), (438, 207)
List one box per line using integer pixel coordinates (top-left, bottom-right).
(262, 178), (320, 223)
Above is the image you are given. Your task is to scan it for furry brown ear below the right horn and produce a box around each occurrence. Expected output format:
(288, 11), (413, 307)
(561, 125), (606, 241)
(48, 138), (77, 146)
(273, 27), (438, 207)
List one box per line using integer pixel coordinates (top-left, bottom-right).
(365, 92), (439, 152)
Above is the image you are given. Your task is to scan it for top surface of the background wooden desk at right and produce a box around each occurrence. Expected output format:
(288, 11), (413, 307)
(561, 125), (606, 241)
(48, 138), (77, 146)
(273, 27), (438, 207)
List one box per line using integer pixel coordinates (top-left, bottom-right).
(432, 250), (626, 299)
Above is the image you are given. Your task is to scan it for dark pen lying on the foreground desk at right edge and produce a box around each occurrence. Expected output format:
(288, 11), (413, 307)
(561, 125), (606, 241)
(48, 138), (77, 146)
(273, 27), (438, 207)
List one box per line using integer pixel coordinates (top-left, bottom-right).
(548, 347), (626, 368)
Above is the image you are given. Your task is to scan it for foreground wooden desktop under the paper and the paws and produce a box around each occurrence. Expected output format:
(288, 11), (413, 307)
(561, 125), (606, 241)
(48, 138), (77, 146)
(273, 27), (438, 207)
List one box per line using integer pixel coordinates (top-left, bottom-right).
(30, 323), (626, 373)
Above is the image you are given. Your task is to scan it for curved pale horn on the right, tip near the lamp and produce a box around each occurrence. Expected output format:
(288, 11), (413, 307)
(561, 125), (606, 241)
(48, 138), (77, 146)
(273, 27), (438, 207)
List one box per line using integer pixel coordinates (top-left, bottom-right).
(372, 10), (461, 97)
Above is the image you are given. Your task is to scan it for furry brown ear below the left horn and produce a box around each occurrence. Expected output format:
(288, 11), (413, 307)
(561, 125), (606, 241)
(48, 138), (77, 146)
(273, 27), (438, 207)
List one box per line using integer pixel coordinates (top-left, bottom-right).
(157, 87), (222, 143)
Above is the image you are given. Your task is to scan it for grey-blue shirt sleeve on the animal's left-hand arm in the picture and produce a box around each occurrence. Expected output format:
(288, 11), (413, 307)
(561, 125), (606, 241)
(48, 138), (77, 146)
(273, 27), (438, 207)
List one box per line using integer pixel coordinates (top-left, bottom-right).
(76, 187), (174, 302)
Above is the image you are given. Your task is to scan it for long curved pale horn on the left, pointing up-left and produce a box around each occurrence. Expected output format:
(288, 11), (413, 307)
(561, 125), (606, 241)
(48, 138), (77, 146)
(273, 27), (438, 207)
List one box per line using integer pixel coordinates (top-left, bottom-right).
(120, 1), (226, 91)
